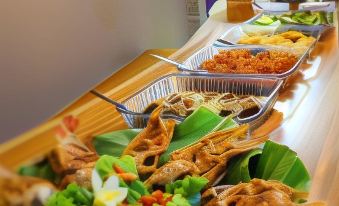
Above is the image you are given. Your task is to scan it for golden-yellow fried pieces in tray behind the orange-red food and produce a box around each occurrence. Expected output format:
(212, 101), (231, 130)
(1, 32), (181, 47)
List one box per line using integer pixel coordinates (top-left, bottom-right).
(238, 31), (316, 55)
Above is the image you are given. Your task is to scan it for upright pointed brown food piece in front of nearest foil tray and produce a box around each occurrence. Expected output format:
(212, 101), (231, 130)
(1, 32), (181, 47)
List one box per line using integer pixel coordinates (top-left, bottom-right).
(123, 106), (175, 175)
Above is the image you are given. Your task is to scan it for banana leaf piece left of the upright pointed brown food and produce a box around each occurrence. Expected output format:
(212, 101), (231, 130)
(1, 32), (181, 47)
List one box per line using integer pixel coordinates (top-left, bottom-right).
(93, 129), (141, 157)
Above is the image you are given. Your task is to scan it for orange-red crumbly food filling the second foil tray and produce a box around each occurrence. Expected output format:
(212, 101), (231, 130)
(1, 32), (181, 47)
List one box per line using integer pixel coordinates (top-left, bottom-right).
(201, 49), (298, 74)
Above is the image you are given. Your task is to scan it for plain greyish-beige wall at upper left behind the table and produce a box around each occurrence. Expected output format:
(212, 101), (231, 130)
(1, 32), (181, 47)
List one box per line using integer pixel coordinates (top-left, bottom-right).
(0, 0), (188, 141)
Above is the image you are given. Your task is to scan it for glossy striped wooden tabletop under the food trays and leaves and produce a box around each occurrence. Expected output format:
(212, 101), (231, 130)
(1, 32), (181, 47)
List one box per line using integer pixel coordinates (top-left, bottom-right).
(0, 7), (339, 205)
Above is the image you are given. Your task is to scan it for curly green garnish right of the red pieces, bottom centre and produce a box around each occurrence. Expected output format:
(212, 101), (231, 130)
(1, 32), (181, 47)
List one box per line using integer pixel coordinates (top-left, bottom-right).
(165, 176), (208, 206)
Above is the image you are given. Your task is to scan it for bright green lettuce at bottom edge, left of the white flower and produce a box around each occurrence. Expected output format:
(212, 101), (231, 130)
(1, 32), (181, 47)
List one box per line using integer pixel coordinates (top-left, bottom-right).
(46, 183), (93, 206)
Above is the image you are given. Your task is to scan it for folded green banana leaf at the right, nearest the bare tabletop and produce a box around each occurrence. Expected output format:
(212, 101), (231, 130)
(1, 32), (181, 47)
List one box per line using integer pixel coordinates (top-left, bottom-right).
(223, 141), (311, 191)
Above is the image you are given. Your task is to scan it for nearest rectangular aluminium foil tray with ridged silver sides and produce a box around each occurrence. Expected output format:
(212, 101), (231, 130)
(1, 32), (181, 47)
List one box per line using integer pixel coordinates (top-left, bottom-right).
(120, 73), (283, 128)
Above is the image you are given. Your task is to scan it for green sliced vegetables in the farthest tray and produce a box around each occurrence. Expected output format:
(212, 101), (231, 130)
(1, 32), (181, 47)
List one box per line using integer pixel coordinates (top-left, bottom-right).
(253, 11), (333, 25)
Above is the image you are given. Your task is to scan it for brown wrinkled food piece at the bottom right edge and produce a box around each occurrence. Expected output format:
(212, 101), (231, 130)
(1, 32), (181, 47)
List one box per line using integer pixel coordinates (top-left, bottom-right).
(202, 179), (316, 206)
